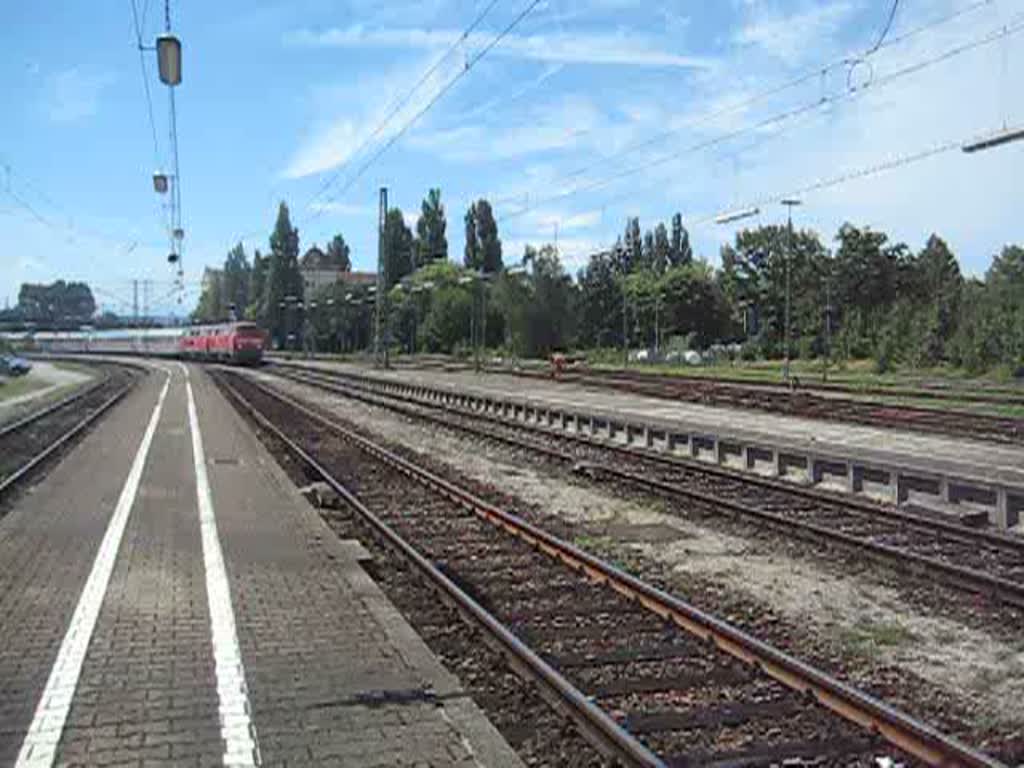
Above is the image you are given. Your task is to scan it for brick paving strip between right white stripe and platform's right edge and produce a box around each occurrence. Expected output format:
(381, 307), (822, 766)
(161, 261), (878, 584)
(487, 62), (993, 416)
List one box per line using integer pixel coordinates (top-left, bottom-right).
(189, 370), (519, 766)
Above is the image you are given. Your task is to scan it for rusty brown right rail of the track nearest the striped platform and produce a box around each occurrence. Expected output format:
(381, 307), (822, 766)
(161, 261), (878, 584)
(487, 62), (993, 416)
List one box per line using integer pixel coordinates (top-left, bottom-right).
(230, 370), (1002, 768)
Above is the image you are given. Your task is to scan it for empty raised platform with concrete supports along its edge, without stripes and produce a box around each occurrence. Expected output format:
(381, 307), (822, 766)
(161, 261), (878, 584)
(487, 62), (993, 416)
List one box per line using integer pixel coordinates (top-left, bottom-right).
(278, 360), (1024, 529)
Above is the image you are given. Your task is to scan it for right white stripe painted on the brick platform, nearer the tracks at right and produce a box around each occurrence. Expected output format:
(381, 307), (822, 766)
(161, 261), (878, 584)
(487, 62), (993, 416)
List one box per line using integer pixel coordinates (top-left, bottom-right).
(184, 364), (260, 768)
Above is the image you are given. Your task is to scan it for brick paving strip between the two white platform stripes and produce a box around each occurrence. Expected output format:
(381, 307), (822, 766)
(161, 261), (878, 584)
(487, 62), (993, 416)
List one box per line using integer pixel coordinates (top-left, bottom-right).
(57, 376), (224, 766)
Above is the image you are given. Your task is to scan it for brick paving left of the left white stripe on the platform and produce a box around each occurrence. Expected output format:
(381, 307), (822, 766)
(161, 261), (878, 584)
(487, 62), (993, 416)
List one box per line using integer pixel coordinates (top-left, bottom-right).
(0, 376), (163, 765)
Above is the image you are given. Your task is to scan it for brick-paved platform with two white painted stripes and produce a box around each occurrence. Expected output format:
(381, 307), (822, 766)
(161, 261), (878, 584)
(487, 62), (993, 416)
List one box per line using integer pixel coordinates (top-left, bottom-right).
(0, 362), (521, 768)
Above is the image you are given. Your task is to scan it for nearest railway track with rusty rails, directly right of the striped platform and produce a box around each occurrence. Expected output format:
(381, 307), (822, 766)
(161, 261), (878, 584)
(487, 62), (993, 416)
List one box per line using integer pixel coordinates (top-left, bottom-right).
(214, 371), (998, 766)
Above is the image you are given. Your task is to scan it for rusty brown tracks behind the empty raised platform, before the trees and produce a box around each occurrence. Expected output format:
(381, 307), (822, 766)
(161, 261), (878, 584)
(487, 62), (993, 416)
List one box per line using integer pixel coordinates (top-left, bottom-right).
(496, 371), (1024, 443)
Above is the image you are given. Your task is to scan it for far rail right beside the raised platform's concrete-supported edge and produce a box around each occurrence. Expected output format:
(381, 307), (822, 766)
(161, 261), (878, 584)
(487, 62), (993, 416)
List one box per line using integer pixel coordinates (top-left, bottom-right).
(274, 364), (1024, 555)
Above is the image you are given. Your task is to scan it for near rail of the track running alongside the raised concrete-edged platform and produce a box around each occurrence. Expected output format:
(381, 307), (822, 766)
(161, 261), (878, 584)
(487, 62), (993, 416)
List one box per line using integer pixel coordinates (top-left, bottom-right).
(268, 364), (1024, 607)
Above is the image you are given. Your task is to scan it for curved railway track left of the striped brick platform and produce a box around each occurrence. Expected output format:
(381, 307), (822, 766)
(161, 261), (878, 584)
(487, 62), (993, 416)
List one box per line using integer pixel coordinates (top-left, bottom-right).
(0, 366), (136, 501)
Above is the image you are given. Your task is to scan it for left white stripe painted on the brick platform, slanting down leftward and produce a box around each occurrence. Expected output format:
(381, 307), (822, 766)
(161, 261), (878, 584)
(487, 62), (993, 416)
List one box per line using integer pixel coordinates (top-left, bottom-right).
(14, 374), (171, 768)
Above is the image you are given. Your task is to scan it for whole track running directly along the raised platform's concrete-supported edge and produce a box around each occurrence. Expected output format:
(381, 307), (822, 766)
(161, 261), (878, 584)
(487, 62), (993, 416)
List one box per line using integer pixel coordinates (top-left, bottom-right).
(262, 369), (1024, 608)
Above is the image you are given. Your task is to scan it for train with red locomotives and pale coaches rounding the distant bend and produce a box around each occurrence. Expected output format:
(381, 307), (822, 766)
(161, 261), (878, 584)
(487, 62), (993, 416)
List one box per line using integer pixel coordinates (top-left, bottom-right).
(12, 323), (267, 365)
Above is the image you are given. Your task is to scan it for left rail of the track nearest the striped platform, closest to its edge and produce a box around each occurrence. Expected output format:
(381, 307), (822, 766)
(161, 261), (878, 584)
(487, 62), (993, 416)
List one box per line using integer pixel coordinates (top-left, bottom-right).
(218, 377), (665, 768)
